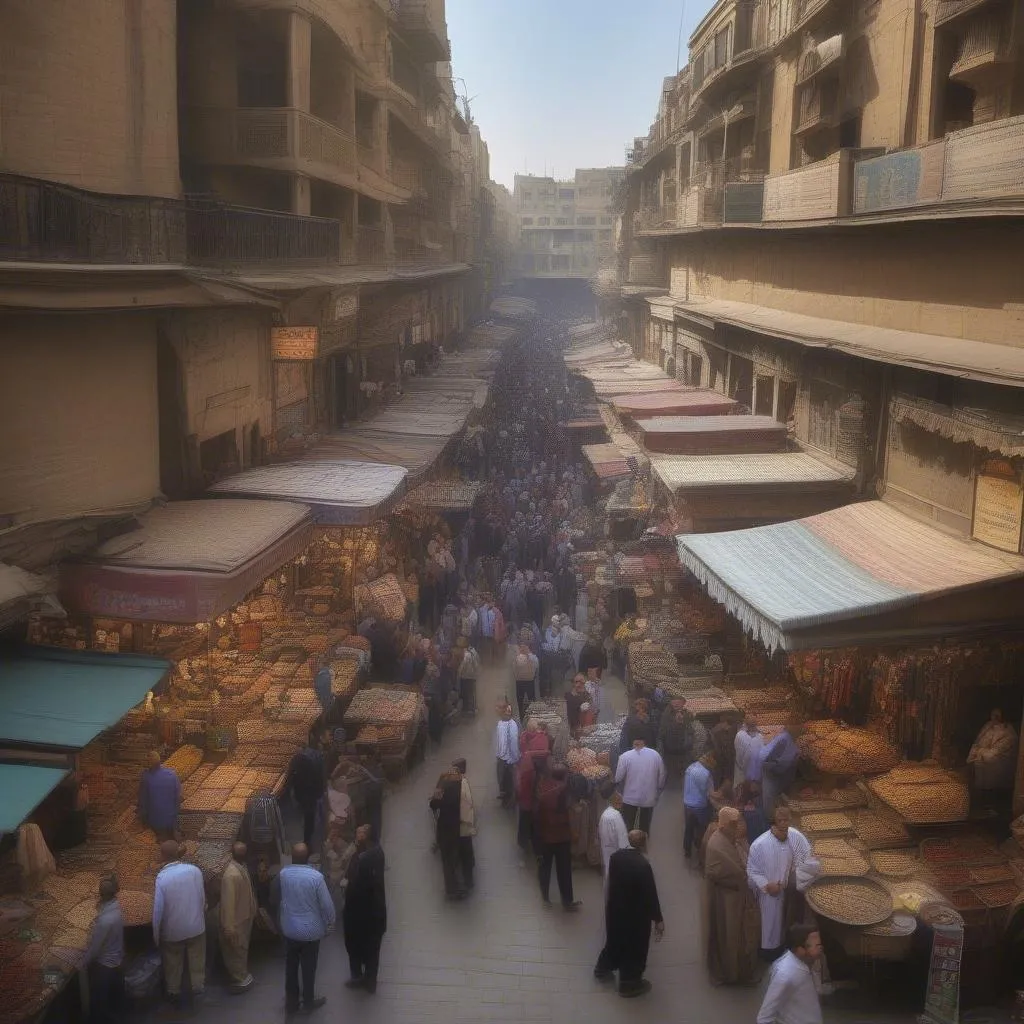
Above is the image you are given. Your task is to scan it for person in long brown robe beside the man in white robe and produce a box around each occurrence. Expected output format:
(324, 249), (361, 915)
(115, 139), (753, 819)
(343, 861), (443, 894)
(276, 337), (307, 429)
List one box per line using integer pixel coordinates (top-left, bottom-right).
(703, 807), (759, 985)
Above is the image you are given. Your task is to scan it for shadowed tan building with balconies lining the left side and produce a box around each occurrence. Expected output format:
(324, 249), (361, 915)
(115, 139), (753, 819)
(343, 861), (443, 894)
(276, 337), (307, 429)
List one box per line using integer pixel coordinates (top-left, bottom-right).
(0, 0), (497, 564)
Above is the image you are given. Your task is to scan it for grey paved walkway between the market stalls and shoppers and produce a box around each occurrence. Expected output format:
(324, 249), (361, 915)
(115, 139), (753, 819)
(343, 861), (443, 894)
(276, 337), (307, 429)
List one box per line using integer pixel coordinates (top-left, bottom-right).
(180, 670), (909, 1024)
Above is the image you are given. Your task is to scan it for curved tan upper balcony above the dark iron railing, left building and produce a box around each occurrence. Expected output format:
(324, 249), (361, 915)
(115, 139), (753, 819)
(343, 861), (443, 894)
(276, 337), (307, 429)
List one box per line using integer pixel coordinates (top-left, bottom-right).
(187, 106), (358, 187)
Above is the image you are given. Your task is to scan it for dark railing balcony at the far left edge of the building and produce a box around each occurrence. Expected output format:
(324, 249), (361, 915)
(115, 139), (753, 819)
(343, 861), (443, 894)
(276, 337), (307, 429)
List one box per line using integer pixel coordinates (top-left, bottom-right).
(0, 174), (185, 265)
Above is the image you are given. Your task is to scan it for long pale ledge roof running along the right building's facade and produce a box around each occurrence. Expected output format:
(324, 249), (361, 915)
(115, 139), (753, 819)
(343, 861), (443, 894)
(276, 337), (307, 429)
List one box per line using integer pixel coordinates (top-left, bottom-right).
(676, 299), (1024, 387)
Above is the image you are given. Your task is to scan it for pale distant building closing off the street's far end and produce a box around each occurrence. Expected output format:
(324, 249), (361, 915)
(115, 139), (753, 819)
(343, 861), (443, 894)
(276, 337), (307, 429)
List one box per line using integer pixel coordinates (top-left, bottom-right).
(513, 167), (626, 280)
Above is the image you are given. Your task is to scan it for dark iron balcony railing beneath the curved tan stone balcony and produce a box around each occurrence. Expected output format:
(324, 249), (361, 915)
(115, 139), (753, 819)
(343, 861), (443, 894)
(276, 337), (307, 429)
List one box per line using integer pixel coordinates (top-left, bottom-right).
(186, 204), (342, 266)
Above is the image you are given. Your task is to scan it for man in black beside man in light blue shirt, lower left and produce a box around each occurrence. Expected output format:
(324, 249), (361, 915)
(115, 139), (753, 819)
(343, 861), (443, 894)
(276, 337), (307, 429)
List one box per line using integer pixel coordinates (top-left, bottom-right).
(341, 825), (387, 992)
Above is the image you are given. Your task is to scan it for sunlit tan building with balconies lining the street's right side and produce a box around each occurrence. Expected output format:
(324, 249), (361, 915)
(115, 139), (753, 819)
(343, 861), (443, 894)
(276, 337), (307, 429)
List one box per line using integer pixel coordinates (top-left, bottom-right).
(622, 0), (1024, 552)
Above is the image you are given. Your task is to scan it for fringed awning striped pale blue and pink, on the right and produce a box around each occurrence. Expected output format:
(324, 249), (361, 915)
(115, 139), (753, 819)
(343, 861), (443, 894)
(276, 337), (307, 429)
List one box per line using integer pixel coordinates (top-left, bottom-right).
(676, 502), (1024, 649)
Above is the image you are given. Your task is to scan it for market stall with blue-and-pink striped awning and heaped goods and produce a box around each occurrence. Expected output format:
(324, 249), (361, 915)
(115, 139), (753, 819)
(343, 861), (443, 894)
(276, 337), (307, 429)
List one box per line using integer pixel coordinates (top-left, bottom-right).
(678, 502), (1024, 1005)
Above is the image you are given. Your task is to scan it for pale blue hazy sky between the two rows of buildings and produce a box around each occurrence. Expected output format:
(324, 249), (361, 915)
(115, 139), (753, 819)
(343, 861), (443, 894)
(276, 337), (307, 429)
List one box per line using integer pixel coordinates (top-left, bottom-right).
(447, 0), (711, 188)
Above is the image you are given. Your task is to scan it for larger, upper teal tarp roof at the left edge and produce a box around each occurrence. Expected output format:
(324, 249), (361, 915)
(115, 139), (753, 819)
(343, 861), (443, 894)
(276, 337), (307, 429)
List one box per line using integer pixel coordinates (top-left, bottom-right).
(0, 647), (171, 750)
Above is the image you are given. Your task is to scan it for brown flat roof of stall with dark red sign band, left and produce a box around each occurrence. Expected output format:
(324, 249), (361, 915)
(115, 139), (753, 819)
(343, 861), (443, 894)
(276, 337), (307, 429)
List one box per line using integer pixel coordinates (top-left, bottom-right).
(91, 498), (311, 573)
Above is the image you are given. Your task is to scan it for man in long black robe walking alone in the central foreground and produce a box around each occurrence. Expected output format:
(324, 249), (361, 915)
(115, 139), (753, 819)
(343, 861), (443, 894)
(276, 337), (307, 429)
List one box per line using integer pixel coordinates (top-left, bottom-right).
(594, 828), (665, 998)
